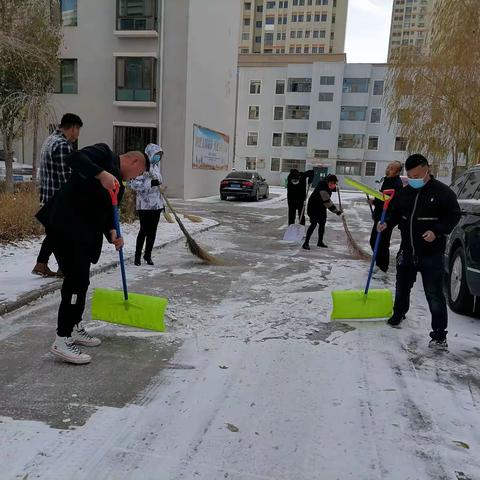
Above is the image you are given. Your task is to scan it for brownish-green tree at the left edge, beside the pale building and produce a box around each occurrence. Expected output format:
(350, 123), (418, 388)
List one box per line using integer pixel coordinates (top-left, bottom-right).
(0, 0), (61, 191)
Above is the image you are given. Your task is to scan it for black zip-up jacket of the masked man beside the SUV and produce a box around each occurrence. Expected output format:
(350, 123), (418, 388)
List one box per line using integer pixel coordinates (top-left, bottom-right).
(387, 177), (460, 257)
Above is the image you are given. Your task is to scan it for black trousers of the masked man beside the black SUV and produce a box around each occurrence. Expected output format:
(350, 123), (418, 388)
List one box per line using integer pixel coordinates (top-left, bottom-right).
(393, 251), (448, 340)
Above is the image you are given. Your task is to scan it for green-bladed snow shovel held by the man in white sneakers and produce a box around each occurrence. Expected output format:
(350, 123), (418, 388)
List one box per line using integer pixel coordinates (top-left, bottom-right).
(92, 189), (168, 332)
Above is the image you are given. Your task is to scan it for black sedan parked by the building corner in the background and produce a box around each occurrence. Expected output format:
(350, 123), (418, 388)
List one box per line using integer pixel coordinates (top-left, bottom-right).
(220, 172), (269, 200)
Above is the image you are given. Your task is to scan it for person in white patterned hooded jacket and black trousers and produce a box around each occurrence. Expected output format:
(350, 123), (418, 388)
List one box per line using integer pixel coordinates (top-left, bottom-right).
(128, 143), (165, 266)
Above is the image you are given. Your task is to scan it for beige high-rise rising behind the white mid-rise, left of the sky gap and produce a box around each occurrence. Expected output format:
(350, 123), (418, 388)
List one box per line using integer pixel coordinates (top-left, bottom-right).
(239, 0), (348, 54)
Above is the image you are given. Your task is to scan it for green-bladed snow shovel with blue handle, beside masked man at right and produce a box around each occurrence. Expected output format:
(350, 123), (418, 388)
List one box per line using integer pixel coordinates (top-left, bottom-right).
(331, 190), (395, 320)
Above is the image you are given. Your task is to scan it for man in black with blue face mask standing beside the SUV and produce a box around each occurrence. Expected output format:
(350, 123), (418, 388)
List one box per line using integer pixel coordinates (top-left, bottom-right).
(378, 154), (460, 350)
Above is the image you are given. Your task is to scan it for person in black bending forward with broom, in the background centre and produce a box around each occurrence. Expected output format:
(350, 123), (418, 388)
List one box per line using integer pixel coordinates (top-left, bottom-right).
(302, 175), (342, 250)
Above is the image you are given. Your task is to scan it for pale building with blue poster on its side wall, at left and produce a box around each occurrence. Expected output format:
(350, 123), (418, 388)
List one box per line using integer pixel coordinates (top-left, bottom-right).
(22, 0), (240, 198)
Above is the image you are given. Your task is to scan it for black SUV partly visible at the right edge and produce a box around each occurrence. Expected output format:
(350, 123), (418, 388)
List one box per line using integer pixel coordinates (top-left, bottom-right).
(445, 165), (480, 313)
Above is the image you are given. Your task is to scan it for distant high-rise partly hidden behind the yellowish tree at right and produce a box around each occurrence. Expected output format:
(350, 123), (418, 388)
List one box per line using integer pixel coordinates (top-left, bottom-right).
(388, 0), (435, 58)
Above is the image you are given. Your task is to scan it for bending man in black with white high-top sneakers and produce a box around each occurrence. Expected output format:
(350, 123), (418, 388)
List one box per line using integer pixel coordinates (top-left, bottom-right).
(36, 143), (150, 364)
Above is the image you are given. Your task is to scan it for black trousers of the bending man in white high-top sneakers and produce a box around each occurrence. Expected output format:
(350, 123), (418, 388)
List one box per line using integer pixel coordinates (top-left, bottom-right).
(49, 233), (90, 337)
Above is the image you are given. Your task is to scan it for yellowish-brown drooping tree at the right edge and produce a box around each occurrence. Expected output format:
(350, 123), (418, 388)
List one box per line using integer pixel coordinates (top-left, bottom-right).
(384, 0), (480, 180)
